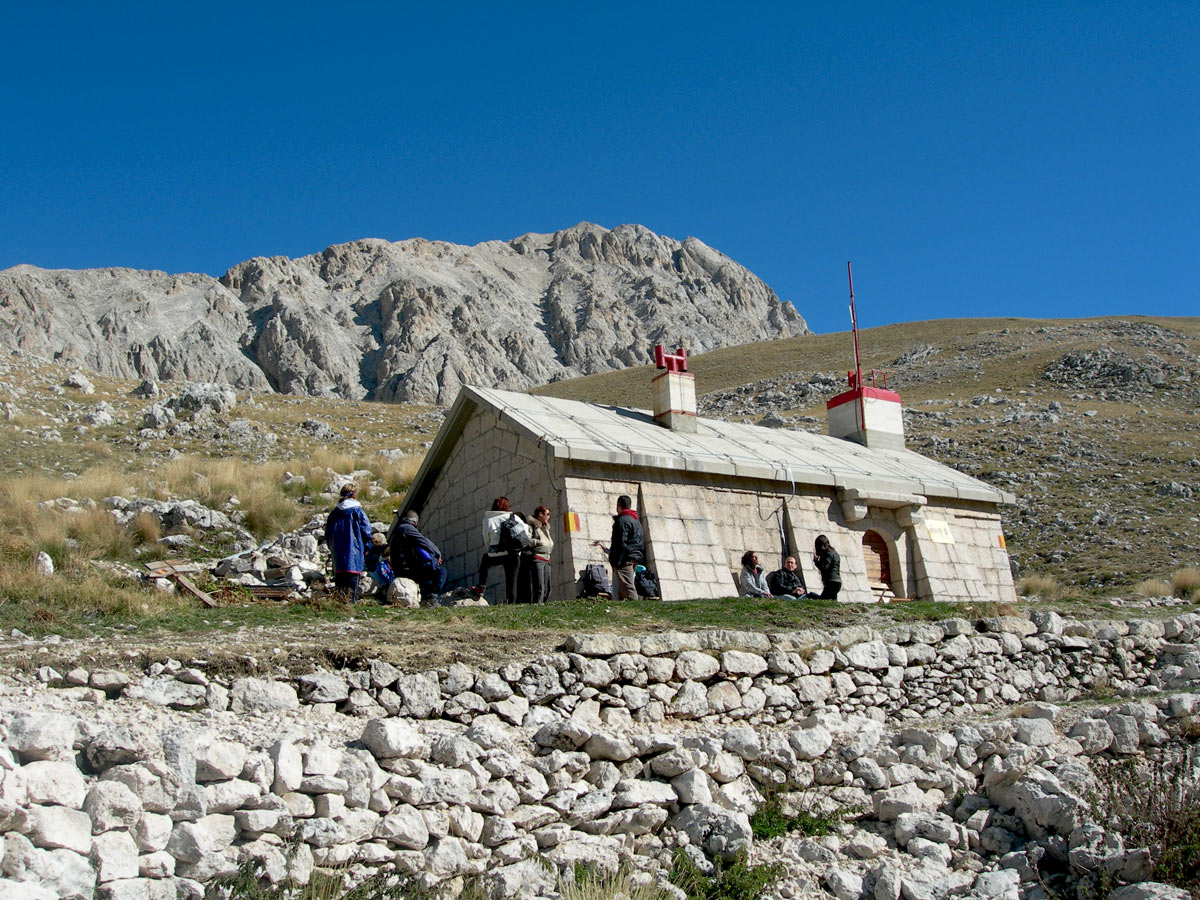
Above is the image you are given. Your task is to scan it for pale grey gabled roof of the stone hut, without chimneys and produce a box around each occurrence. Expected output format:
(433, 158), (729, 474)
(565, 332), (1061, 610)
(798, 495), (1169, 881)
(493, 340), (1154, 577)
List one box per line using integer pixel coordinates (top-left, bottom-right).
(404, 386), (1015, 509)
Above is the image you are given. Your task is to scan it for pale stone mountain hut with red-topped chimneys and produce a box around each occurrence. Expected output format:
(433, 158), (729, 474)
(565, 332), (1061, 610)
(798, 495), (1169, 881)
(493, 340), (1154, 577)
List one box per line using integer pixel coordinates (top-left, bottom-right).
(402, 348), (1014, 601)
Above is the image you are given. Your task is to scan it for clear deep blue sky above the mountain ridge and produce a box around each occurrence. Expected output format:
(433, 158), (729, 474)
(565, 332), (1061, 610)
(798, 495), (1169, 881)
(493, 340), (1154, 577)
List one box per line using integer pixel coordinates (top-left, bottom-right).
(0, 0), (1200, 331)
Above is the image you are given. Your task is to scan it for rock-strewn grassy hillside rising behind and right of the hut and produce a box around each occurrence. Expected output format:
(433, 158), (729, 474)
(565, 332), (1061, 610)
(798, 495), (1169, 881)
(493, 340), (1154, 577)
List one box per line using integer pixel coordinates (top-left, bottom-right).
(539, 317), (1200, 594)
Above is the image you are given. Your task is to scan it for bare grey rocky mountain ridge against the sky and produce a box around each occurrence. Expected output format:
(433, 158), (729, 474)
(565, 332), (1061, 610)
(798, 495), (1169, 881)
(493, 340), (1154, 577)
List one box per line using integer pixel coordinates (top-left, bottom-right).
(0, 223), (809, 403)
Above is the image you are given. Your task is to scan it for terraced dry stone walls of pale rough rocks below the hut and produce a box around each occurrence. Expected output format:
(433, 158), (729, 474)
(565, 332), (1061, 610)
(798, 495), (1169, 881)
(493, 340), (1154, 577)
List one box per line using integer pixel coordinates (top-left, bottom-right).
(0, 612), (1200, 900)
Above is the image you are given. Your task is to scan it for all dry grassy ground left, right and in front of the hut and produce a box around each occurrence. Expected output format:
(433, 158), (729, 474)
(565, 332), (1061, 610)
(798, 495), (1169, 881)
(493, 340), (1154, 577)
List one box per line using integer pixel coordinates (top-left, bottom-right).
(0, 317), (1200, 665)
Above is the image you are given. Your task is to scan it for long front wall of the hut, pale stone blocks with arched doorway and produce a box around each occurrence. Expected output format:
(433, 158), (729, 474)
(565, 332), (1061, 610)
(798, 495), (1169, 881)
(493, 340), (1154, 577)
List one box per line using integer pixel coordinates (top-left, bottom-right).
(564, 464), (1014, 601)
